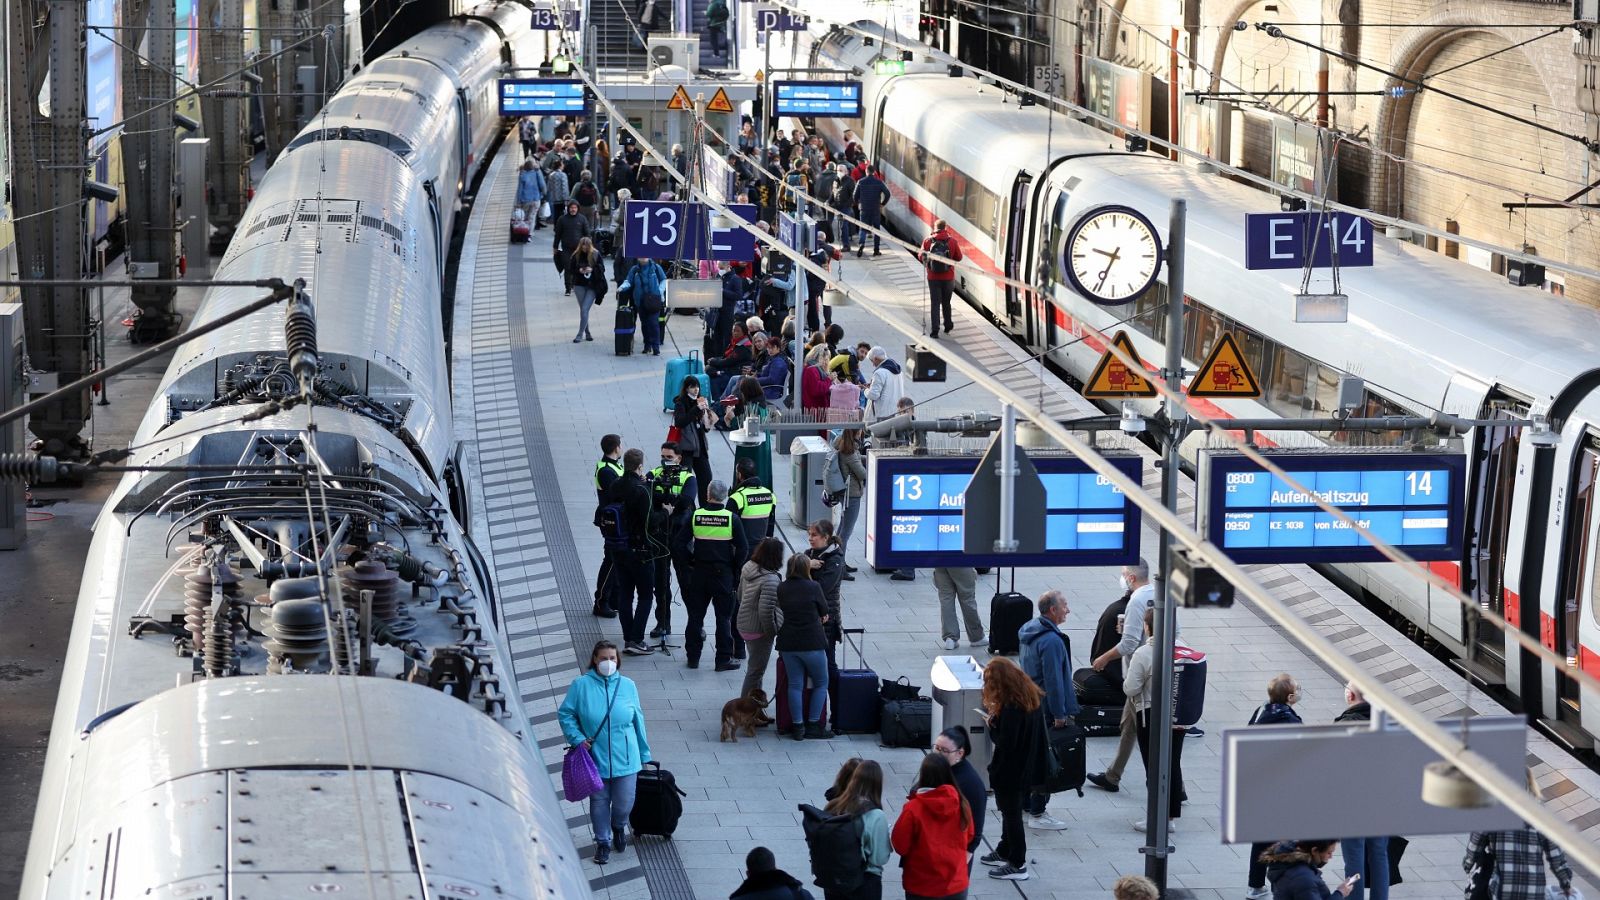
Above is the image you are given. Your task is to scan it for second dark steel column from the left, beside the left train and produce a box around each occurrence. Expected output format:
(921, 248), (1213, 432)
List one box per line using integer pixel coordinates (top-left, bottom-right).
(122, 0), (179, 343)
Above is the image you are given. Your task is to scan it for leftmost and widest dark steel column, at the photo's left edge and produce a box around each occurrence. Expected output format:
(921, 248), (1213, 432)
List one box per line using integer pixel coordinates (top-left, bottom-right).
(6, 0), (91, 455)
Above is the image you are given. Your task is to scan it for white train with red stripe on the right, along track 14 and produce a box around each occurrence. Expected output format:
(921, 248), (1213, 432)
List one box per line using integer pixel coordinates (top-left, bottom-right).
(810, 22), (1600, 746)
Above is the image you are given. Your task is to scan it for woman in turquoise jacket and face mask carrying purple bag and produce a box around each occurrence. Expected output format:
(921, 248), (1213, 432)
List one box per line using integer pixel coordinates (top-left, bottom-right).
(555, 641), (650, 865)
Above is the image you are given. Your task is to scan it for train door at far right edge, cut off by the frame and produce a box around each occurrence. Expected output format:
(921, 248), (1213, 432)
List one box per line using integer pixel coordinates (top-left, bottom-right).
(1555, 434), (1600, 727)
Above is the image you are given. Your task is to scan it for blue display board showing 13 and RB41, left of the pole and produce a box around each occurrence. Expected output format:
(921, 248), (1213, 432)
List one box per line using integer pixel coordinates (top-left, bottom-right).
(866, 453), (1142, 569)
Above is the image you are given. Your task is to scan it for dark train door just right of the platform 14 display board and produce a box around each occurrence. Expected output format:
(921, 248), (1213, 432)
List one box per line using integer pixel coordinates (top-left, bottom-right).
(1461, 391), (1528, 684)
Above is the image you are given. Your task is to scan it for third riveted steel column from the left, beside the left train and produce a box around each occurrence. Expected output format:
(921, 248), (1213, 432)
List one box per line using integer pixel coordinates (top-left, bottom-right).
(197, 0), (253, 248)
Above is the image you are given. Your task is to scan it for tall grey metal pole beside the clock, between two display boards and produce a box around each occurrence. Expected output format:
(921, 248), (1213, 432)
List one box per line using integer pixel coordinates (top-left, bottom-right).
(1142, 197), (1189, 894)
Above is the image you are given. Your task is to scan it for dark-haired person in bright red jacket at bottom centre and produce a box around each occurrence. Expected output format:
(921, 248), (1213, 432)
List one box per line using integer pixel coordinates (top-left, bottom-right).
(890, 753), (974, 900)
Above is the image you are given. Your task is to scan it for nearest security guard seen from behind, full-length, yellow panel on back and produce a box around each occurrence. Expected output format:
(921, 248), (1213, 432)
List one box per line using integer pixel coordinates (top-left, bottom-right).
(680, 480), (750, 673)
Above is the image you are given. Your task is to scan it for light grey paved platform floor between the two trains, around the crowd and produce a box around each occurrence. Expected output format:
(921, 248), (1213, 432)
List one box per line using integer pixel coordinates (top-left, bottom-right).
(453, 146), (1600, 900)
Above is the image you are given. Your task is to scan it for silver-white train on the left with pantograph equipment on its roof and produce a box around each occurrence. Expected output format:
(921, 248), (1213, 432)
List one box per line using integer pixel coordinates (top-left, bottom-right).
(22, 2), (589, 900)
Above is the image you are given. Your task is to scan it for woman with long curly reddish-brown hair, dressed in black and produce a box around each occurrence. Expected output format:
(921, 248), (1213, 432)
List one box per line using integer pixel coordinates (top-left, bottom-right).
(979, 657), (1050, 881)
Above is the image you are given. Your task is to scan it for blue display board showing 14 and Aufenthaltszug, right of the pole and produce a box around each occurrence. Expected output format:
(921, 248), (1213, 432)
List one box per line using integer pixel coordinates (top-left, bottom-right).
(1200, 450), (1466, 564)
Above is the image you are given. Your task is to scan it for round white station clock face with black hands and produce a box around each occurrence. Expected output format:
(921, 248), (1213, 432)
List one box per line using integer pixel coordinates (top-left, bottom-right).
(1064, 207), (1162, 306)
